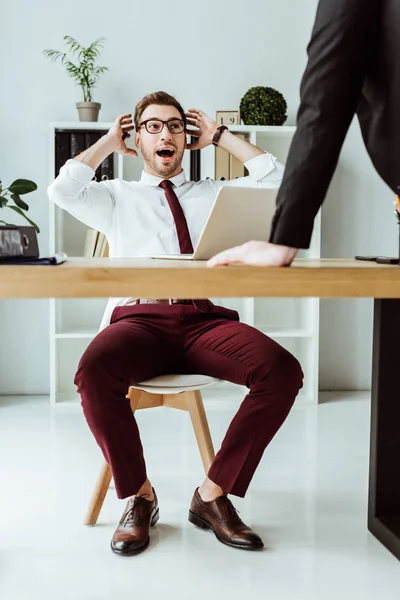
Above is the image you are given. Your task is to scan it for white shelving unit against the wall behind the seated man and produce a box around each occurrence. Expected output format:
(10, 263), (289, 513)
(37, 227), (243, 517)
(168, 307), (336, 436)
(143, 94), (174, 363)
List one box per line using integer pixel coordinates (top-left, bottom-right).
(49, 122), (320, 404)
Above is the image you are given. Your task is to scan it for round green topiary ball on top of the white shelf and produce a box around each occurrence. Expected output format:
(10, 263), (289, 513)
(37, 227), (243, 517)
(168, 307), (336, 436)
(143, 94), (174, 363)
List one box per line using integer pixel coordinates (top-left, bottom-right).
(240, 86), (287, 125)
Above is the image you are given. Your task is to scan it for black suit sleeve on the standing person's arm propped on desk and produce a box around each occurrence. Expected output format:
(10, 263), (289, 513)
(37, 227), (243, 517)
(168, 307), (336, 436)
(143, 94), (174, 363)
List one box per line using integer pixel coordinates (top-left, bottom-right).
(270, 0), (381, 248)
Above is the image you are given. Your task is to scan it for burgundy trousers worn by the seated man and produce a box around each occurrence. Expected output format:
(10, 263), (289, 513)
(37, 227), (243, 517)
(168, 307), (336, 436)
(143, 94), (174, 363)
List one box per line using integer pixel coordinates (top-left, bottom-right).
(75, 304), (303, 498)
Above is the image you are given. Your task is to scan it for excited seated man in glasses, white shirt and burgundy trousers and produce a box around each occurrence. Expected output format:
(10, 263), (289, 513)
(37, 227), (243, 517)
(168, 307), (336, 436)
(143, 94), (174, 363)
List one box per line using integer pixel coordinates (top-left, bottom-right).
(48, 92), (303, 555)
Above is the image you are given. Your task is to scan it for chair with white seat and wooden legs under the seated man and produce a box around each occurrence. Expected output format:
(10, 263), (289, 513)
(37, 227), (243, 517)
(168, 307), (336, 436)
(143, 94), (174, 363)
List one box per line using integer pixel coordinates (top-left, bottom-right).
(84, 375), (220, 525)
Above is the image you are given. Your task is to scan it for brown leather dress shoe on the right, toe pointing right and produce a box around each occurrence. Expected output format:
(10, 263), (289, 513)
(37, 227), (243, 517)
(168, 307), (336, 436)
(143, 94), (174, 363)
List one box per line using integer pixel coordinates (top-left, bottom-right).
(189, 488), (264, 550)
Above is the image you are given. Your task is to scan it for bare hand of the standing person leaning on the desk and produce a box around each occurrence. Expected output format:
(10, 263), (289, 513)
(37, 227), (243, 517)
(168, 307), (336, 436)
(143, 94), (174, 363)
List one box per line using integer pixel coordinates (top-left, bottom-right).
(207, 242), (297, 267)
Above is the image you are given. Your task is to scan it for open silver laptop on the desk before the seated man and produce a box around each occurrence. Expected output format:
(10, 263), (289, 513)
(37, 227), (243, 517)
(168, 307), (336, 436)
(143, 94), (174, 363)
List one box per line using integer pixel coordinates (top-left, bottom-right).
(151, 186), (278, 260)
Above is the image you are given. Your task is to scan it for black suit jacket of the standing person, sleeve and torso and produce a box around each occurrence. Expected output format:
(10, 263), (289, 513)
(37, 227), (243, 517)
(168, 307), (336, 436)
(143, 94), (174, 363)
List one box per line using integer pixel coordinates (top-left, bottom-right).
(270, 0), (400, 248)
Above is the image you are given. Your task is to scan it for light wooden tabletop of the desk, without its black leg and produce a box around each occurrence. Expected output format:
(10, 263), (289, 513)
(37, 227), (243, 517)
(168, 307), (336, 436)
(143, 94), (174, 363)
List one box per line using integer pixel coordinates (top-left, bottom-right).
(0, 258), (400, 298)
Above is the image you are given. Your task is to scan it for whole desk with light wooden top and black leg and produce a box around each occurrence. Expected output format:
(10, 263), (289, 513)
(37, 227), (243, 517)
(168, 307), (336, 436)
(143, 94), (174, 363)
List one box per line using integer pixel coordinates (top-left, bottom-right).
(0, 258), (400, 559)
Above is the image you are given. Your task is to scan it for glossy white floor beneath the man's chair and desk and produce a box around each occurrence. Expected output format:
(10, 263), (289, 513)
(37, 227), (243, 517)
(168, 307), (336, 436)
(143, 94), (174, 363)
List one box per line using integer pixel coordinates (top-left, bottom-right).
(0, 393), (400, 600)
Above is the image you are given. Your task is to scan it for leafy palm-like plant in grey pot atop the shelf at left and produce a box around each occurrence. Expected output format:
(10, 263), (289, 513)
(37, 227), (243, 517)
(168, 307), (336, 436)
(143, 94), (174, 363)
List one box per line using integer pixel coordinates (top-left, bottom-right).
(43, 35), (108, 121)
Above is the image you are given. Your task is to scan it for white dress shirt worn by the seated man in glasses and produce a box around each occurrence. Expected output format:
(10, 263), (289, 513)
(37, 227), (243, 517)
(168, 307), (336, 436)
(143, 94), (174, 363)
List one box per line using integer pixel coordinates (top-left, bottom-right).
(48, 153), (284, 328)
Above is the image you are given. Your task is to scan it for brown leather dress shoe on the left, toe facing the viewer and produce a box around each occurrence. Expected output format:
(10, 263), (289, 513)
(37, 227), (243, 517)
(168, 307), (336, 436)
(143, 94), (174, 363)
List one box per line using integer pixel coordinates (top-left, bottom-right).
(111, 489), (159, 556)
